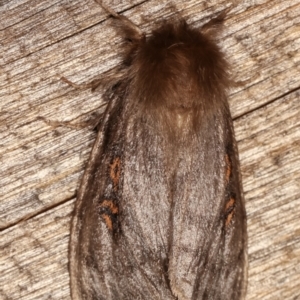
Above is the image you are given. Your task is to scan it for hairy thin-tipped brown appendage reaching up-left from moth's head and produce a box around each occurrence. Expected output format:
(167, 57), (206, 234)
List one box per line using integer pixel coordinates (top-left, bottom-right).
(95, 0), (144, 42)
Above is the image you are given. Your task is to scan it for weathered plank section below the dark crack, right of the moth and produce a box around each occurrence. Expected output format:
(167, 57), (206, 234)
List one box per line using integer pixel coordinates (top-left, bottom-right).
(235, 91), (300, 300)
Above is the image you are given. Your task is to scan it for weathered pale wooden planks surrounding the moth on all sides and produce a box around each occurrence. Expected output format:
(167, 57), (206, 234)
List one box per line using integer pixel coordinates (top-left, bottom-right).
(0, 0), (300, 300)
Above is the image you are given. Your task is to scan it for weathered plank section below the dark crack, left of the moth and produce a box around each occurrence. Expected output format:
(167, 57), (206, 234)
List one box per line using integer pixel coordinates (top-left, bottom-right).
(0, 201), (74, 300)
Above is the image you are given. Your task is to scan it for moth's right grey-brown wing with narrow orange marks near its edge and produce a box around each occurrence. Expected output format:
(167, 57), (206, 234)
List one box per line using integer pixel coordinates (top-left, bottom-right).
(169, 109), (247, 300)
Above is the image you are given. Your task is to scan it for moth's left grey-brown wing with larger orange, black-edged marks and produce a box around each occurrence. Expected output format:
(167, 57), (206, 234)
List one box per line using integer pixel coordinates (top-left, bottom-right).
(70, 99), (176, 300)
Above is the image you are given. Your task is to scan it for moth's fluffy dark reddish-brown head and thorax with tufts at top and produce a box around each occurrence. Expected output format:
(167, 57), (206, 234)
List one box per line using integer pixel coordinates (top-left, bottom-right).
(105, 5), (230, 135)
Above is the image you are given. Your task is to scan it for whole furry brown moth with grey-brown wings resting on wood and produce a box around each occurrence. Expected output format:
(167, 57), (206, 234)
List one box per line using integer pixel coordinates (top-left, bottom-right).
(70, 4), (247, 300)
